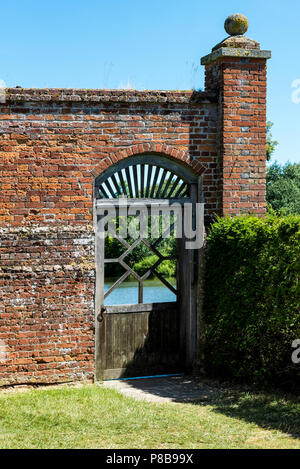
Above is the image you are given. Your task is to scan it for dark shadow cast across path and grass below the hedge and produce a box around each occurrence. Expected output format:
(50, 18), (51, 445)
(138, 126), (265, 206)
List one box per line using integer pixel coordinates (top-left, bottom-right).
(116, 376), (300, 439)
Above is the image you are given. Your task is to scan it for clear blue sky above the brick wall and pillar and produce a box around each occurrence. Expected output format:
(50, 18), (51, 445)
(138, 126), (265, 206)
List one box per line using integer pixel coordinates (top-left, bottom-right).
(0, 0), (300, 163)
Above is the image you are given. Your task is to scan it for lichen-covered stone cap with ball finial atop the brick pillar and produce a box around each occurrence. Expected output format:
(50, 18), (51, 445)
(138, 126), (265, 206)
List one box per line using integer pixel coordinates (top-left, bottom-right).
(201, 13), (271, 65)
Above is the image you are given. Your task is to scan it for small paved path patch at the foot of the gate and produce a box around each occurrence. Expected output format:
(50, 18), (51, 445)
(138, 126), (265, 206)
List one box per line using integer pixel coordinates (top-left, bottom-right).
(101, 376), (216, 402)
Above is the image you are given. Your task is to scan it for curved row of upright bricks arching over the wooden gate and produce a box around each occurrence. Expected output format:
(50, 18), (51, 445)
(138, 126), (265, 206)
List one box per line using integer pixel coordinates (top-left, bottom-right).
(91, 143), (207, 178)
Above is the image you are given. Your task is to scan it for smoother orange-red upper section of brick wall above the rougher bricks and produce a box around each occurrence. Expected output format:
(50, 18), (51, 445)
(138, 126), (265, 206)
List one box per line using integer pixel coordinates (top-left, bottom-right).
(0, 89), (217, 226)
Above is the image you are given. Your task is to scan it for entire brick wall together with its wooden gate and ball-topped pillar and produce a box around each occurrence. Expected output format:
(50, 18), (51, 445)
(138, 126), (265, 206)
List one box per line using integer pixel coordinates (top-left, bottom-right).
(0, 15), (271, 386)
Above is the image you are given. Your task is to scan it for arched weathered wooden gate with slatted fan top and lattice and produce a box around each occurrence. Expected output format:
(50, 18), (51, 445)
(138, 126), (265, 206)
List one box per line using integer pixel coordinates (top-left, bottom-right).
(95, 154), (204, 379)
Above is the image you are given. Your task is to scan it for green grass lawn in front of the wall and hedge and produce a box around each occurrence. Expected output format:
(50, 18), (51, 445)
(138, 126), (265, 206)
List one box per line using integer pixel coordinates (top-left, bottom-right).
(0, 385), (300, 449)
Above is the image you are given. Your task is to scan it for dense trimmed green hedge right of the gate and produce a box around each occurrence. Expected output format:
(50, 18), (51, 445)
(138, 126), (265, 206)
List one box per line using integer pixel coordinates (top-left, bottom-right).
(204, 215), (300, 390)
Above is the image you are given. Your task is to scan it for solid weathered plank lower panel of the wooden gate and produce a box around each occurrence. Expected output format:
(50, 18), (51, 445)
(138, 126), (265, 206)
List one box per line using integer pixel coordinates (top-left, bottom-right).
(101, 302), (184, 379)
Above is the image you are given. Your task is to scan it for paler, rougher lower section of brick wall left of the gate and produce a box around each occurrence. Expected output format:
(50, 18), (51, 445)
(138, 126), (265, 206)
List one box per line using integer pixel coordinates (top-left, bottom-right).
(0, 225), (95, 385)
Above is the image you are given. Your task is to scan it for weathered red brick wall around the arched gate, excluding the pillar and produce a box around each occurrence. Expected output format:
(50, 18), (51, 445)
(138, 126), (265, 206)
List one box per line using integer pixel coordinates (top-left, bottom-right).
(0, 89), (218, 385)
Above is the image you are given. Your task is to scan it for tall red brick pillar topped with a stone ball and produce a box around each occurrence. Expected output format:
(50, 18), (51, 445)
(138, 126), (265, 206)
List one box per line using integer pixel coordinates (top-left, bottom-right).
(201, 15), (271, 216)
